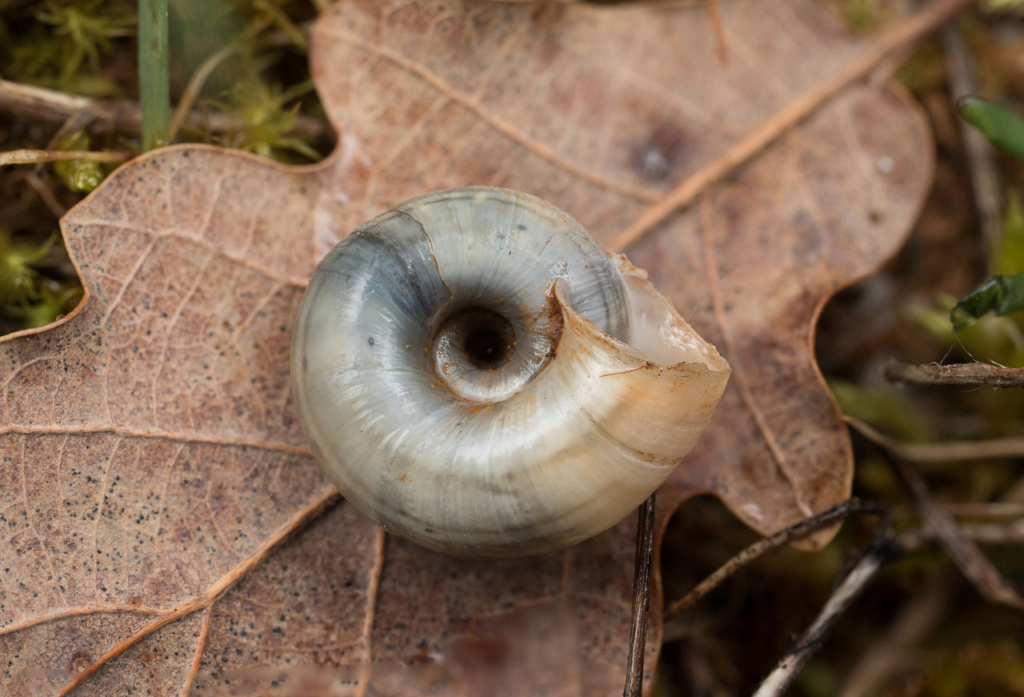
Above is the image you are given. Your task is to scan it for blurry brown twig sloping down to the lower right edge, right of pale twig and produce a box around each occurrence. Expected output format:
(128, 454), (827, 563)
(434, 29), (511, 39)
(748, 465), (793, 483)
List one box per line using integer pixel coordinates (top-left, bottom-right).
(895, 462), (1024, 610)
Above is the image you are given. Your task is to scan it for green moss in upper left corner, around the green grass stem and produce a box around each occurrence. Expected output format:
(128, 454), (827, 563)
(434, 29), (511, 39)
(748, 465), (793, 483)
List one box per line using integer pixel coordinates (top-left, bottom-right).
(0, 0), (322, 333)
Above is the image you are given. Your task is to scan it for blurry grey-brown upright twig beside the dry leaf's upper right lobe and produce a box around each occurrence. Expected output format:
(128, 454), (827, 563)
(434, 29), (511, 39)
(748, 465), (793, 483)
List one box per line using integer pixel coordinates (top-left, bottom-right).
(942, 25), (1002, 256)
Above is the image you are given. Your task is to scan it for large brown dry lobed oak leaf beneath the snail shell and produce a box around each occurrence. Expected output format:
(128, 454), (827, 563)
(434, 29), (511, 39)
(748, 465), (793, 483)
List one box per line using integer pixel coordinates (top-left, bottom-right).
(0, 0), (931, 695)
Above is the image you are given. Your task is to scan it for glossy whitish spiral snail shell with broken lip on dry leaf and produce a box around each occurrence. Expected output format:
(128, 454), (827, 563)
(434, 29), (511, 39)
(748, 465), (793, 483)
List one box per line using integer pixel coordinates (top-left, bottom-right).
(292, 186), (730, 557)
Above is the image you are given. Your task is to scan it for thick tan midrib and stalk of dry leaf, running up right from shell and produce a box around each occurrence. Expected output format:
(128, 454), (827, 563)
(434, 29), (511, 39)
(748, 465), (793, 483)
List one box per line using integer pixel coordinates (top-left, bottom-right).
(608, 0), (974, 252)
